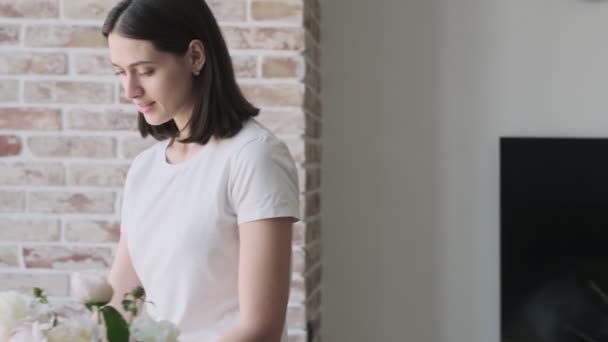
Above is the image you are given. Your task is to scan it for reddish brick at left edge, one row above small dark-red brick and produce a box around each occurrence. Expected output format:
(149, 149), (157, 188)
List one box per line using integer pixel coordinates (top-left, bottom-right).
(0, 107), (61, 131)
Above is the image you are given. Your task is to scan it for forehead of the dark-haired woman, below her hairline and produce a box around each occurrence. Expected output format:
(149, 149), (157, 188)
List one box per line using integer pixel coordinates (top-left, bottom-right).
(108, 33), (165, 67)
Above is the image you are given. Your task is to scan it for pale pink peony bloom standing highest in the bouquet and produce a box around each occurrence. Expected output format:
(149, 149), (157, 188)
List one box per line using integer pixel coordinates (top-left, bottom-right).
(70, 272), (114, 304)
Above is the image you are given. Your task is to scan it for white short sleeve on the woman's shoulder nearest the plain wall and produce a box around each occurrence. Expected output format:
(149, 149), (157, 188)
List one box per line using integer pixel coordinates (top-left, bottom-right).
(229, 137), (300, 224)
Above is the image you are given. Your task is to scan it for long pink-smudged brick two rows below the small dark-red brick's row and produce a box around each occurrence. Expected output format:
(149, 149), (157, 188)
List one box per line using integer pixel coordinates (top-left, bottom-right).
(28, 191), (115, 214)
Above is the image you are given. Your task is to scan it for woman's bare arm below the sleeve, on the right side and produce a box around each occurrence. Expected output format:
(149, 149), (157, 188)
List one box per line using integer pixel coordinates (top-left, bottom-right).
(220, 218), (293, 342)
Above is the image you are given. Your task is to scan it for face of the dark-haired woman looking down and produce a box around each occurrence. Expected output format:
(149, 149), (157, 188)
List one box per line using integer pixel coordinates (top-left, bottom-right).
(108, 33), (194, 128)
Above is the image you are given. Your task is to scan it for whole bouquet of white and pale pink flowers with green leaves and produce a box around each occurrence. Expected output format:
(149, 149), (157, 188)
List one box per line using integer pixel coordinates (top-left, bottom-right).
(0, 272), (179, 342)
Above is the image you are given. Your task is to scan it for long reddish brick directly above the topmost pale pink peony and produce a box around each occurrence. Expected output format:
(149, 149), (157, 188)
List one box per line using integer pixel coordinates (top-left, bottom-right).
(23, 246), (112, 270)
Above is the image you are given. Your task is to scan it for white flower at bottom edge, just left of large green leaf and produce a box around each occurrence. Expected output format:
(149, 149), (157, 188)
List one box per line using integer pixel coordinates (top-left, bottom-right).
(46, 315), (99, 342)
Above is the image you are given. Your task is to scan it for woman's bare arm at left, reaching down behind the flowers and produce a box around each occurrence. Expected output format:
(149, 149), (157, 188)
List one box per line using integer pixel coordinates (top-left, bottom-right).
(108, 232), (142, 319)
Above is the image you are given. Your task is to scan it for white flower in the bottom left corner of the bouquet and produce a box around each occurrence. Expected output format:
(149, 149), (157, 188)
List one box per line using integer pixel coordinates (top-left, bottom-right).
(0, 291), (40, 341)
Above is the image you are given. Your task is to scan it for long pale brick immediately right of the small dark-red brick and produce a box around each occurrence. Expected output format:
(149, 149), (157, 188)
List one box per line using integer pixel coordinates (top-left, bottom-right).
(28, 136), (116, 158)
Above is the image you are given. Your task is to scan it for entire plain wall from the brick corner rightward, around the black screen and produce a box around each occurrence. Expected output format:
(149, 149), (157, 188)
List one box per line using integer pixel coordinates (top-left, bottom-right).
(323, 0), (608, 342)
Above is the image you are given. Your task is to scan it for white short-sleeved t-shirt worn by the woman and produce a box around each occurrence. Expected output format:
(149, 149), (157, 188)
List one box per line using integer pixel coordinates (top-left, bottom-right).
(122, 119), (300, 342)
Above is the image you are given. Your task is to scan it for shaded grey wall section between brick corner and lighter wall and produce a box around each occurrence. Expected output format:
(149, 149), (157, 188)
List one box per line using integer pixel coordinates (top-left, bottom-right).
(322, 0), (439, 342)
